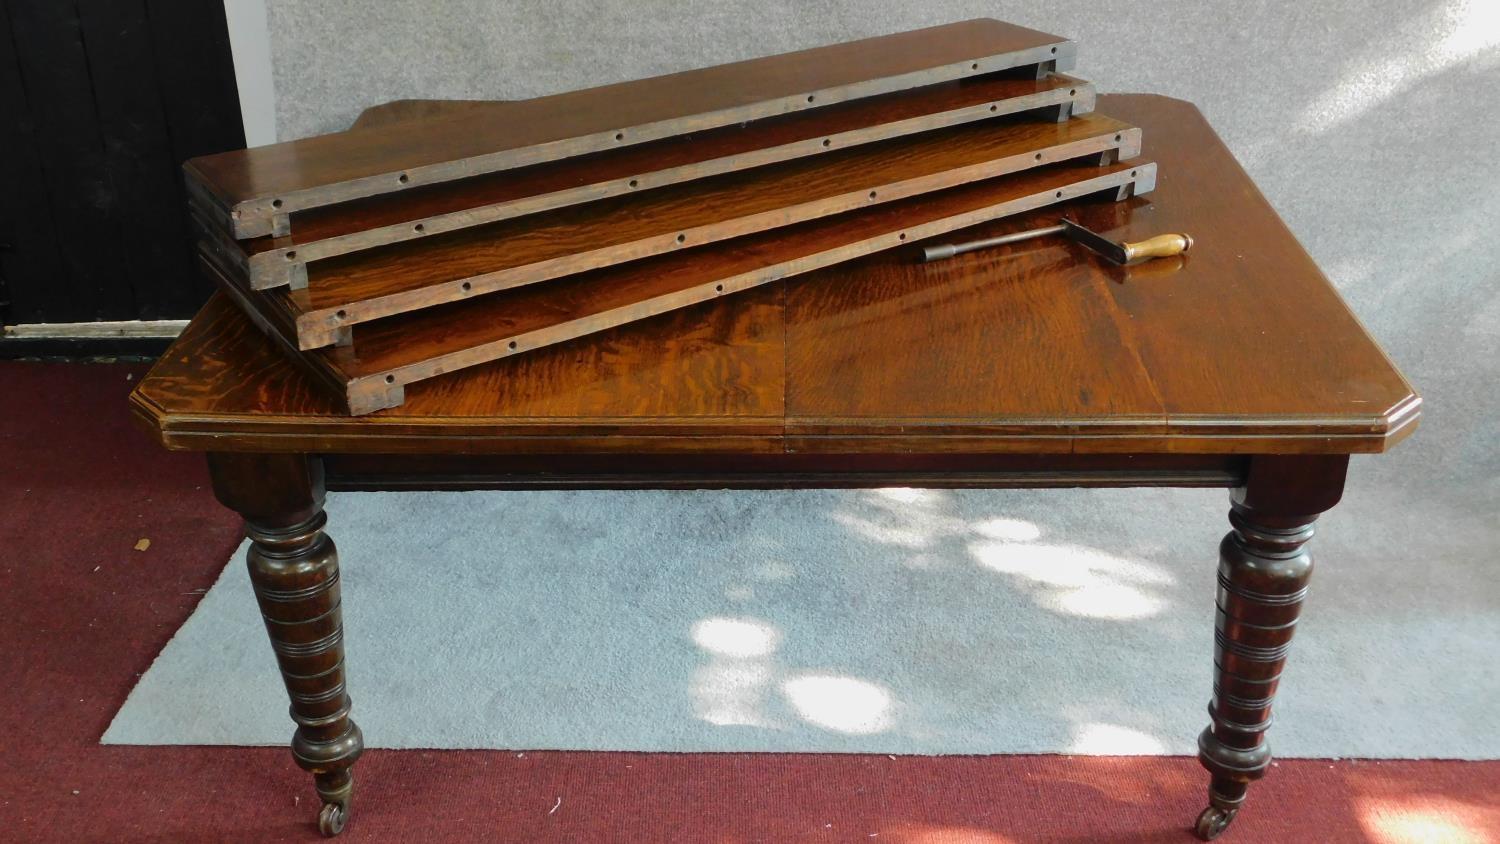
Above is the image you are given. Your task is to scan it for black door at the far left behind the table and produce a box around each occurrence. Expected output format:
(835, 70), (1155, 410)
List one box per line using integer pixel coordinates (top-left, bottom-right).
(0, 0), (245, 324)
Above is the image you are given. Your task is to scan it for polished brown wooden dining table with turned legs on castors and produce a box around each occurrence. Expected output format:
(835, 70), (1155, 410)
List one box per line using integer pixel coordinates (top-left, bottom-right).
(132, 96), (1421, 838)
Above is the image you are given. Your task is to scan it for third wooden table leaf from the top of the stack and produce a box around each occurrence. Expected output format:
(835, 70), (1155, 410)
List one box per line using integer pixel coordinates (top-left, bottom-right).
(287, 114), (1140, 349)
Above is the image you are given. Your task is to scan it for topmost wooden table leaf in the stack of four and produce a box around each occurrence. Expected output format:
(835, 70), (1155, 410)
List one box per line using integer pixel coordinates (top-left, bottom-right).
(185, 19), (1074, 238)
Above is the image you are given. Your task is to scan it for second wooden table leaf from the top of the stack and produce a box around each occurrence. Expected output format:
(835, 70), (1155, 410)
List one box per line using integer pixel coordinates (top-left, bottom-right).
(219, 73), (1092, 289)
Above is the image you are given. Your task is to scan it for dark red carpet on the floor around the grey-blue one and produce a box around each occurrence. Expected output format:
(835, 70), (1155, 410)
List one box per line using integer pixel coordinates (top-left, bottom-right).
(0, 363), (1500, 844)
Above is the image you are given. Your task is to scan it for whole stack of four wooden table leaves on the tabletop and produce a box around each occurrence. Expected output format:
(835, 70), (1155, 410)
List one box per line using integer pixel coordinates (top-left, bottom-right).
(188, 21), (1155, 414)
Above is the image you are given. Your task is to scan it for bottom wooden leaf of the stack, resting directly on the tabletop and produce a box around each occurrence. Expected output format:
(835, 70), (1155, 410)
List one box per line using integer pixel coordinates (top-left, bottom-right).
(206, 163), (1155, 414)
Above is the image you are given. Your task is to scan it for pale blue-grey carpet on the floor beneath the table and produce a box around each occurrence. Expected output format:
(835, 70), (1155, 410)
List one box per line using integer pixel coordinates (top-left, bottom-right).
(104, 482), (1500, 759)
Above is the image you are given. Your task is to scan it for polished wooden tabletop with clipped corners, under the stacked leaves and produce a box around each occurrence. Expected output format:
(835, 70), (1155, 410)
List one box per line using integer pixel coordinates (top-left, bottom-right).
(132, 96), (1421, 460)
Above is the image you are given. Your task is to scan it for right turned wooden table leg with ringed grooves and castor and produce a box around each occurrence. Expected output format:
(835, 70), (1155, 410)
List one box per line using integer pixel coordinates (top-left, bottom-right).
(1194, 456), (1349, 841)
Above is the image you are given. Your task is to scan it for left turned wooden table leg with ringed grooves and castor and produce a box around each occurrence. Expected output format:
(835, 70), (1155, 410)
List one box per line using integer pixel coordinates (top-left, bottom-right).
(209, 453), (365, 835)
